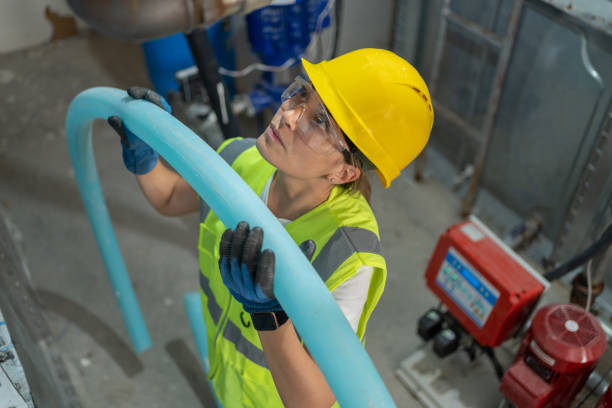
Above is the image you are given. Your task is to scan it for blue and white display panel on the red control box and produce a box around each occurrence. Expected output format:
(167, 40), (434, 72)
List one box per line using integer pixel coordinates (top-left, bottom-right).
(436, 248), (499, 327)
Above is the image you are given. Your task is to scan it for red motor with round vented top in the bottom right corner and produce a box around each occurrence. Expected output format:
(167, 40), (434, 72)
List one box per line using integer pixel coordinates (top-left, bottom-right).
(500, 304), (607, 408)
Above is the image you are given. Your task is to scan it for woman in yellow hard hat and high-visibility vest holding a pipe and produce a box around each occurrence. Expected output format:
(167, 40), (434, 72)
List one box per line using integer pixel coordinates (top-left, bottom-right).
(109, 49), (433, 408)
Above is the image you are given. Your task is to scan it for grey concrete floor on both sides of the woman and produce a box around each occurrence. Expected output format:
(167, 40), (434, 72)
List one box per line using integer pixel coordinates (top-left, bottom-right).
(0, 33), (468, 408)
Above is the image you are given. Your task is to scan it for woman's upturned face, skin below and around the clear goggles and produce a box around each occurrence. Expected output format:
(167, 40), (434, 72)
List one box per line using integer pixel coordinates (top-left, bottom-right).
(257, 84), (352, 184)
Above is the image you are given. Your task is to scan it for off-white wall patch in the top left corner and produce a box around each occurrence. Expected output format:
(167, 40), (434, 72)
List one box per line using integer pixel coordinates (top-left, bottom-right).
(0, 0), (81, 53)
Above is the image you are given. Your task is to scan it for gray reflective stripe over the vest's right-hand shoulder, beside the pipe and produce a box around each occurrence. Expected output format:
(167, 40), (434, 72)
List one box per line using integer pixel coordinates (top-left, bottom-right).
(312, 227), (382, 282)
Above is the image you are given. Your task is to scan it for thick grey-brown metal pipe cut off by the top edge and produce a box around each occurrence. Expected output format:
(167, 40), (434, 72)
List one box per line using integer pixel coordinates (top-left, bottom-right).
(68, 0), (272, 41)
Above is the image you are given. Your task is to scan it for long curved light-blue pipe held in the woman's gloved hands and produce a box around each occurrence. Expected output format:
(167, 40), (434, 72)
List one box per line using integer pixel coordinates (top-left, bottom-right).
(66, 88), (395, 408)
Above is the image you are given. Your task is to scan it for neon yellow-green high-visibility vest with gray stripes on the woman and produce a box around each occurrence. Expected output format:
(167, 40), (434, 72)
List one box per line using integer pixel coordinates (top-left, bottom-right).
(198, 138), (387, 408)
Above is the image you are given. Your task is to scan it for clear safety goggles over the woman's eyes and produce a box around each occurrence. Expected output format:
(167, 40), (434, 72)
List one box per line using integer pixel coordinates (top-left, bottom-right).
(281, 76), (350, 156)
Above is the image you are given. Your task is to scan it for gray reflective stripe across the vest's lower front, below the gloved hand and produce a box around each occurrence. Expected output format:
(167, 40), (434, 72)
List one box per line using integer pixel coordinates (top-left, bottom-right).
(200, 272), (268, 368)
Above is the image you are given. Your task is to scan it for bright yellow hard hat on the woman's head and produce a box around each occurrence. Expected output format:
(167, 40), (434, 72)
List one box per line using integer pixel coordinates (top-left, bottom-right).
(302, 48), (434, 187)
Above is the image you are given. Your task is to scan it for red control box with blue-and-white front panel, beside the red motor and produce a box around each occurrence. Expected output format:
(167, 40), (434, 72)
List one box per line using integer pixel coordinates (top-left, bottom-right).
(425, 216), (549, 347)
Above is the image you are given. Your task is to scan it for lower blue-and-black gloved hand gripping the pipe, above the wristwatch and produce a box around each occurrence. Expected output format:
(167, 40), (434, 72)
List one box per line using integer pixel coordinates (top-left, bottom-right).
(219, 221), (315, 313)
